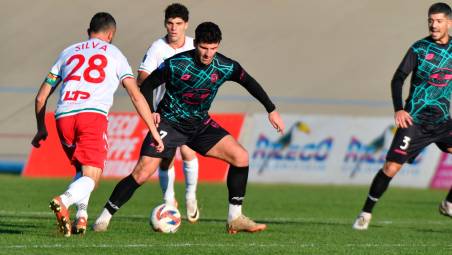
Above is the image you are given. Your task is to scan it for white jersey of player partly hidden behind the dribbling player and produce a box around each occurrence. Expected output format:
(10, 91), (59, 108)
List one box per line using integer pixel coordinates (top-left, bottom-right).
(138, 36), (194, 110)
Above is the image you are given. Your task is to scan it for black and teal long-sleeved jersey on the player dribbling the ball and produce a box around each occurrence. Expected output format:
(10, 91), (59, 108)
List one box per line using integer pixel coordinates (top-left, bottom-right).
(141, 50), (275, 130)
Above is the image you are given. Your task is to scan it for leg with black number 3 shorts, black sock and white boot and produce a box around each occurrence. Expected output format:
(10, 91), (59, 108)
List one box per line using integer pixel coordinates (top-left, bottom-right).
(353, 125), (431, 230)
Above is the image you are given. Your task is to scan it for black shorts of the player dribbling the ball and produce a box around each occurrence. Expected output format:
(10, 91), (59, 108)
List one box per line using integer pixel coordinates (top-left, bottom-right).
(140, 118), (229, 159)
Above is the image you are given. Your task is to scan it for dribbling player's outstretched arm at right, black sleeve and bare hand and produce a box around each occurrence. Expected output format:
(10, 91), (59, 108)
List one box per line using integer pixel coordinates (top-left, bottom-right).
(231, 63), (285, 134)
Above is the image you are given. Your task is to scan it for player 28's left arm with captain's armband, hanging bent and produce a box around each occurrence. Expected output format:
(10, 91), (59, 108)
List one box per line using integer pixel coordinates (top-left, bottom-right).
(31, 73), (61, 148)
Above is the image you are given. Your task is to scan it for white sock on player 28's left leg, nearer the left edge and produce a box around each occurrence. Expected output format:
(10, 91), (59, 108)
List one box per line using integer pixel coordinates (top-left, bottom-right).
(60, 176), (96, 208)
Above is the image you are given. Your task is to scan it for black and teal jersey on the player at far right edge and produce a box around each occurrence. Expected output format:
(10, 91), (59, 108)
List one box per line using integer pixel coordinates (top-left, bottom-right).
(392, 37), (452, 124)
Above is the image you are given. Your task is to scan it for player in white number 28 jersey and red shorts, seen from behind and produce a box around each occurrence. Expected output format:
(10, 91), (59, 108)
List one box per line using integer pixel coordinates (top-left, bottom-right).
(32, 12), (163, 237)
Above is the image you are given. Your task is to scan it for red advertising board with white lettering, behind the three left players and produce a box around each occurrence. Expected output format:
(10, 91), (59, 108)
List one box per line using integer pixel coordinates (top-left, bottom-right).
(23, 113), (244, 181)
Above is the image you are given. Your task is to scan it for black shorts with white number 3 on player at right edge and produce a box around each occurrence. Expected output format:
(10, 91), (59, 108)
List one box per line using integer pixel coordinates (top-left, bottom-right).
(386, 120), (452, 164)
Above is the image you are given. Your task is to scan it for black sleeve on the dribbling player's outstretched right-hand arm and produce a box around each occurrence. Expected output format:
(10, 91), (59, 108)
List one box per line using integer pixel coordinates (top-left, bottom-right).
(230, 61), (276, 113)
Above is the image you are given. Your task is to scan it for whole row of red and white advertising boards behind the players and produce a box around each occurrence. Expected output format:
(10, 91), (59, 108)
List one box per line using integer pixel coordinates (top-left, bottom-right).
(22, 113), (452, 188)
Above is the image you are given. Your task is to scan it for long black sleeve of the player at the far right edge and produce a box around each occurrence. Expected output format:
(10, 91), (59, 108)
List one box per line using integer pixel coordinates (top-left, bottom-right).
(391, 47), (417, 112)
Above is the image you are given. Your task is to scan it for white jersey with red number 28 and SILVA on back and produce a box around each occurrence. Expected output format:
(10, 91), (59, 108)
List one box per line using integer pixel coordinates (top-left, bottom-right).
(49, 38), (134, 118)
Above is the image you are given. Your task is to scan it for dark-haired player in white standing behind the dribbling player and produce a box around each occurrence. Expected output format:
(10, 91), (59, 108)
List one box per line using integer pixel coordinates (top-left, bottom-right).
(138, 3), (199, 223)
